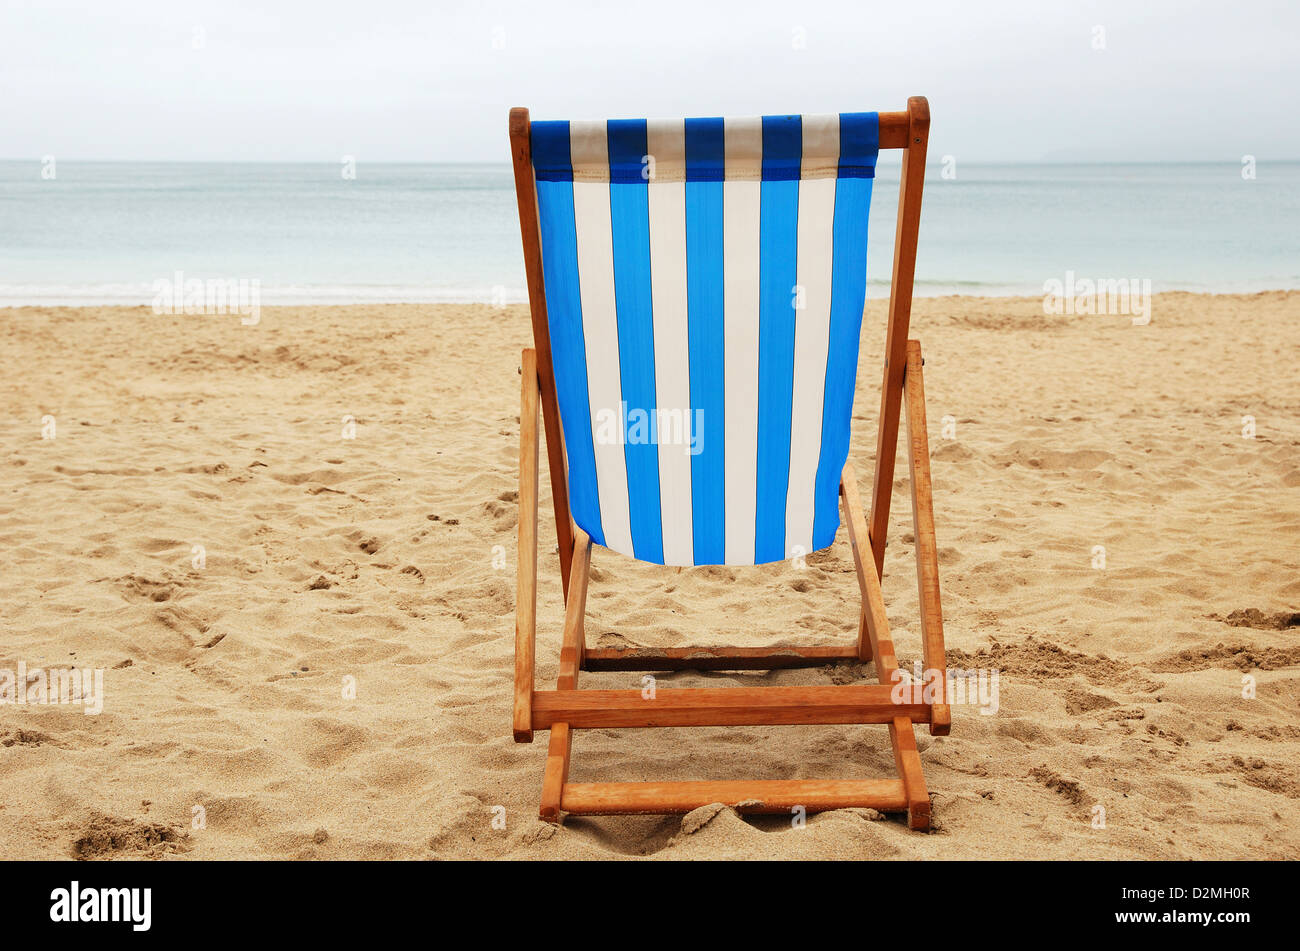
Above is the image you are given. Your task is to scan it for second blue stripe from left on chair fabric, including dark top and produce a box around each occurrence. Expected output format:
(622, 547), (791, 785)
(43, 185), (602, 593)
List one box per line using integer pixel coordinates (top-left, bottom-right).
(607, 120), (663, 564)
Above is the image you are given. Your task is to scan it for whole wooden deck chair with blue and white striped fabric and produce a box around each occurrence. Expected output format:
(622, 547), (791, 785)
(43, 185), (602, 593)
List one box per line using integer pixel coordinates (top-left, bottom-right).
(510, 97), (952, 829)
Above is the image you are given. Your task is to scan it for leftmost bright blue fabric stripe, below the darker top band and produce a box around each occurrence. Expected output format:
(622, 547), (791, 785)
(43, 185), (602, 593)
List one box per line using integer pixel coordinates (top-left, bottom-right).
(537, 181), (605, 544)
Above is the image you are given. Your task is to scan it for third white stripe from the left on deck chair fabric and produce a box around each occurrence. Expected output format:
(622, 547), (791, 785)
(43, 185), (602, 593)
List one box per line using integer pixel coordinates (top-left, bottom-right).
(722, 118), (763, 565)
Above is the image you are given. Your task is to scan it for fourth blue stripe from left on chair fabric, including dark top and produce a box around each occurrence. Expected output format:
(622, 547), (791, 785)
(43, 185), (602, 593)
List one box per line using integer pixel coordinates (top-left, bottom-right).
(754, 116), (803, 564)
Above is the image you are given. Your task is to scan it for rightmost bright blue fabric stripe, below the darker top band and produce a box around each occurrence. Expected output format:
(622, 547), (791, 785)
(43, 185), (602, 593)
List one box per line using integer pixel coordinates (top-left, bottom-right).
(813, 178), (871, 551)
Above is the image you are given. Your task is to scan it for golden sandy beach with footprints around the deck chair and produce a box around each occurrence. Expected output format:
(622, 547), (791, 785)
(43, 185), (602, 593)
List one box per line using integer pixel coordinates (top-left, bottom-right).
(0, 292), (1300, 859)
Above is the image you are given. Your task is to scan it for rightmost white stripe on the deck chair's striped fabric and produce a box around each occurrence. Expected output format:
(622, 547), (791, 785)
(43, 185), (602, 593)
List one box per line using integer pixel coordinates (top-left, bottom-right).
(785, 126), (840, 557)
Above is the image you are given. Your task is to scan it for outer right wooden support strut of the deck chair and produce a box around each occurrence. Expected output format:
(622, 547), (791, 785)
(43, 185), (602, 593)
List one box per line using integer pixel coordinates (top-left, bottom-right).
(905, 340), (953, 737)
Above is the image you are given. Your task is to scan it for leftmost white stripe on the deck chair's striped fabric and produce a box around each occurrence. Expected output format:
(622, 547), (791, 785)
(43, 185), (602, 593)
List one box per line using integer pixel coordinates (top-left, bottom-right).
(569, 122), (633, 555)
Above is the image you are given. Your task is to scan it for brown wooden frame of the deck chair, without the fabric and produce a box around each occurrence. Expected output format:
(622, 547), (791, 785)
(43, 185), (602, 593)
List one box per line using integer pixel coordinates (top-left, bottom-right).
(510, 96), (952, 829)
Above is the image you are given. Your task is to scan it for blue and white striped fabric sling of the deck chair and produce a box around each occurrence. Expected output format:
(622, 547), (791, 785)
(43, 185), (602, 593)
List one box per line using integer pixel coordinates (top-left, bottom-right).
(532, 113), (879, 565)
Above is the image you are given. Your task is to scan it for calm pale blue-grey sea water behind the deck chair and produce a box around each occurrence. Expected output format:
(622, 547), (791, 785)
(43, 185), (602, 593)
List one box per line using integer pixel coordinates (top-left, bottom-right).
(0, 155), (1300, 305)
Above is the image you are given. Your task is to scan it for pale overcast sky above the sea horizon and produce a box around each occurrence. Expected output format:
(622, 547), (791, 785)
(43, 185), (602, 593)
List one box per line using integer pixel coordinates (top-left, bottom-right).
(0, 0), (1300, 162)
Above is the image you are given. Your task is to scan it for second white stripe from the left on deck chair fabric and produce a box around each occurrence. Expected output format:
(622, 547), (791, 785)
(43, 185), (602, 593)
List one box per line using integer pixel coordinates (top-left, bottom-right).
(646, 120), (696, 565)
